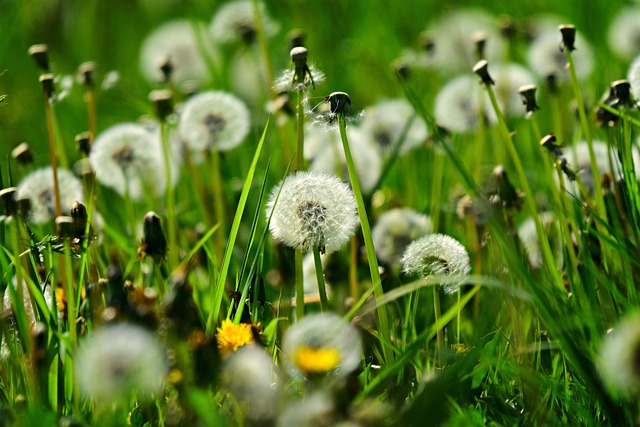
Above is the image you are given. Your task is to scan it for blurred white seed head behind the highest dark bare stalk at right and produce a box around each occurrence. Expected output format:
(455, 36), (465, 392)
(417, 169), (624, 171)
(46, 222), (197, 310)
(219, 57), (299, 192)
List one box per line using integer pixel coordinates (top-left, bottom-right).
(527, 28), (593, 81)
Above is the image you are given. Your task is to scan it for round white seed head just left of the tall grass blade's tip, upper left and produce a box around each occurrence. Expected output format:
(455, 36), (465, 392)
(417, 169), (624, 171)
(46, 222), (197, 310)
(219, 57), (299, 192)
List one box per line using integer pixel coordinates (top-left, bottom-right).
(178, 91), (250, 154)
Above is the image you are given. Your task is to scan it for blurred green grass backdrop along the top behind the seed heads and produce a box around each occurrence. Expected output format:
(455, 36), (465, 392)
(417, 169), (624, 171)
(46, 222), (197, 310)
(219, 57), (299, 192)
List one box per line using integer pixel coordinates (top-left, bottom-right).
(0, 0), (628, 164)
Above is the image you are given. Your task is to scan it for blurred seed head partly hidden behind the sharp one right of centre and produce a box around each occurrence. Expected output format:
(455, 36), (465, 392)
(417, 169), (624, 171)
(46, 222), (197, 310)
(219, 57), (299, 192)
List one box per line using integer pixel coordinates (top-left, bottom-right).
(371, 208), (433, 267)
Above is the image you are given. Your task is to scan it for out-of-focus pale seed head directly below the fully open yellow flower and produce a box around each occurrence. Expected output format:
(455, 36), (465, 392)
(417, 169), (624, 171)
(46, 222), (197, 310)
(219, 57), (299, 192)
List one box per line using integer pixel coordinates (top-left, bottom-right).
(220, 345), (280, 423)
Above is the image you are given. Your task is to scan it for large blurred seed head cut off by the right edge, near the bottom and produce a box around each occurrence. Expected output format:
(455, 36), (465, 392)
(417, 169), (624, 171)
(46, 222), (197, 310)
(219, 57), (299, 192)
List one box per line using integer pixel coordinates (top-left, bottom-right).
(598, 312), (640, 395)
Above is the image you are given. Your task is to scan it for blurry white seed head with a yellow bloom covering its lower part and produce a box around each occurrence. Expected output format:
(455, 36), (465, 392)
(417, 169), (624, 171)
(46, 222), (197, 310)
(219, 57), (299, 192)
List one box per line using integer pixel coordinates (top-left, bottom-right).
(282, 312), (362, 378)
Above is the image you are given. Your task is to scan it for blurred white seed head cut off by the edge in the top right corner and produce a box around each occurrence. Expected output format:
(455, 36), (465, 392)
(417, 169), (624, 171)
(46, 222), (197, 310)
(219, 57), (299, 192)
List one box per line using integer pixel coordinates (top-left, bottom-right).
(607, 6), (640, 60)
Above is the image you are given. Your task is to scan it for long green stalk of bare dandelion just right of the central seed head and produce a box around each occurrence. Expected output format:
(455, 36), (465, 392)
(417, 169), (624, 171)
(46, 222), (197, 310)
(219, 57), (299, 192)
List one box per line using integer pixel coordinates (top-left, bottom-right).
(338, 114), (393, 364)
